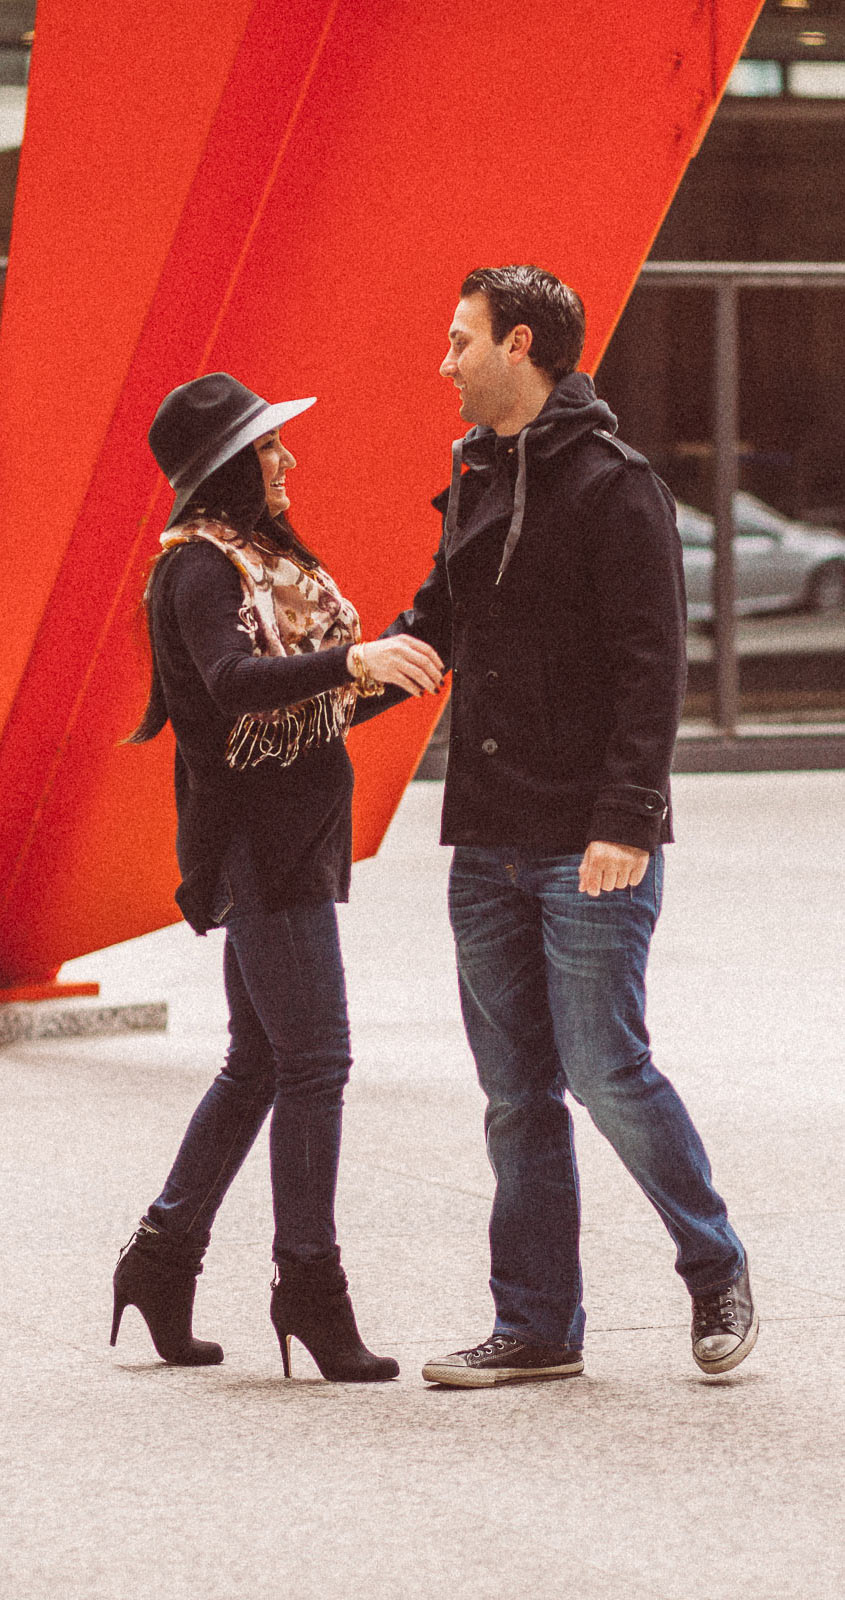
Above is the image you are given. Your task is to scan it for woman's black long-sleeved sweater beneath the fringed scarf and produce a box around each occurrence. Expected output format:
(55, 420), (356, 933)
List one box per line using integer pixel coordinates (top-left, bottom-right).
(150, 541), (352, 933)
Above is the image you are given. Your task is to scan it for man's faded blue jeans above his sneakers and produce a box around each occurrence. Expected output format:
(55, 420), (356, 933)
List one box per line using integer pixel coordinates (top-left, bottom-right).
(450, 846), (744, 1349)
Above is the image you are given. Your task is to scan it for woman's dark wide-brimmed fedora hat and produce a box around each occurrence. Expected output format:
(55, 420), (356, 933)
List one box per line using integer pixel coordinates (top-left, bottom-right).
(147, 373), (314, 528)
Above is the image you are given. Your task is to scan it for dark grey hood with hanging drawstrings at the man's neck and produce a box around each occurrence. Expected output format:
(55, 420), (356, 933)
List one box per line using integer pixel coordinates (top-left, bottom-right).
(445, 373), (616, 584)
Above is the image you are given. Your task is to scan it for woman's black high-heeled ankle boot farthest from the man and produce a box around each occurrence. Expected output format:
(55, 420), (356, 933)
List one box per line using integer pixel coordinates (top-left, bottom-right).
(110, 1222), (222, 1366)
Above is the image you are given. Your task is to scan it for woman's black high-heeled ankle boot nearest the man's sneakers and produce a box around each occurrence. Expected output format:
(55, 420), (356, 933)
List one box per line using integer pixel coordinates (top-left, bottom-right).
(270, 1248), (398, 1384)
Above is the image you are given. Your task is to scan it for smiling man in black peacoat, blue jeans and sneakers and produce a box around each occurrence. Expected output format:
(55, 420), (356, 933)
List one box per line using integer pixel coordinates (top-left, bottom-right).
(366, 266), (757, 1387)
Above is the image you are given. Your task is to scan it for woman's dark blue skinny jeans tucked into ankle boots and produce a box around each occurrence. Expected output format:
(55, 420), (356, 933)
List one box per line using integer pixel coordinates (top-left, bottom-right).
(146, 901), (352, 1261)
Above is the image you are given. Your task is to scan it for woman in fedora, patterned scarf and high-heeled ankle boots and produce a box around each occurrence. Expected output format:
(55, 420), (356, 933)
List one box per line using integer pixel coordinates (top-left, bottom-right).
(112, 373), (442, 1381)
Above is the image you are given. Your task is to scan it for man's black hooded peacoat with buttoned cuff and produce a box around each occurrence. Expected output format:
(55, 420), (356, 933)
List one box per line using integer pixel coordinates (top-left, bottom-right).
(362, 373), (687, 854)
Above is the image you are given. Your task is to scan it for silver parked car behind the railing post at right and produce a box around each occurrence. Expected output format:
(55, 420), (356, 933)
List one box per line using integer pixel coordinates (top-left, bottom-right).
(677, 491), (845, 622)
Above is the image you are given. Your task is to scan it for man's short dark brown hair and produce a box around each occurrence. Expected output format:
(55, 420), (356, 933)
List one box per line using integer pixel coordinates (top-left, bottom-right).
(461, 266), (584, 382)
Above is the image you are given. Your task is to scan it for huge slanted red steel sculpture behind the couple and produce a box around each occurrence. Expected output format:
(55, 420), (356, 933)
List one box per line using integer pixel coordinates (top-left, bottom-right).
(0, 0), (760, 998)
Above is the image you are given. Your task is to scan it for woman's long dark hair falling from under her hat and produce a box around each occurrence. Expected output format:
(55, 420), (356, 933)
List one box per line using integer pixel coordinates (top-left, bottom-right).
(123, 445), (320, 744)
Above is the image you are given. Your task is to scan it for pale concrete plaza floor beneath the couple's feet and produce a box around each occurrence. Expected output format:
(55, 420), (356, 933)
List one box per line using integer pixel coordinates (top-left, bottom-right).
(0, 773), (845, 1600)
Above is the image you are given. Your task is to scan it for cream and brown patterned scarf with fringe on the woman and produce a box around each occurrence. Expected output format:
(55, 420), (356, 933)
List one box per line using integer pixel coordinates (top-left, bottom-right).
(162, 522), (362, 773)
